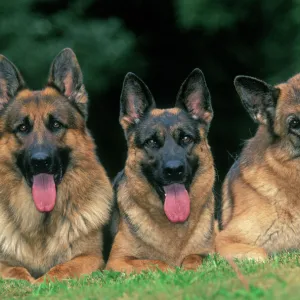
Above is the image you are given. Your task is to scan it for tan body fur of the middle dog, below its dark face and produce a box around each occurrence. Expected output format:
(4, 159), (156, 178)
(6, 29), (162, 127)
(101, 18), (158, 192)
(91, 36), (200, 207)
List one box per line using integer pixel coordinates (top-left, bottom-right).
(106, 110), (215, 273)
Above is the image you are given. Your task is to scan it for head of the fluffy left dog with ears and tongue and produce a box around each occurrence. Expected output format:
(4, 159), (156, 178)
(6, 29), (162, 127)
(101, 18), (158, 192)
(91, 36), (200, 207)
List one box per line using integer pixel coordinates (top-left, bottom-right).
(0, 49), (87, 212)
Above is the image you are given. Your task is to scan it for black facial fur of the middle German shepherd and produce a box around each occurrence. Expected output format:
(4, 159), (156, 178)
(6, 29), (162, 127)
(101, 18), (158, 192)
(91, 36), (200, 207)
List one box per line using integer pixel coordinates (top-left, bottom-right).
(135, 111), (201, 201)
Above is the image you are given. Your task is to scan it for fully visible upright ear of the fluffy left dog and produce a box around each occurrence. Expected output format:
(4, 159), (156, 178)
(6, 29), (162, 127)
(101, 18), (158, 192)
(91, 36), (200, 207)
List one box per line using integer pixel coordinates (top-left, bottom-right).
(48, 48), (88, 116)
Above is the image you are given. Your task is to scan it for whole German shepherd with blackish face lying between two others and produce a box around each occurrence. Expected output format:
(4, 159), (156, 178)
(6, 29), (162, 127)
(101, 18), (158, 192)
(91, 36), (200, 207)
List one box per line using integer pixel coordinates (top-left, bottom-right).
(106, 69), (215, 273)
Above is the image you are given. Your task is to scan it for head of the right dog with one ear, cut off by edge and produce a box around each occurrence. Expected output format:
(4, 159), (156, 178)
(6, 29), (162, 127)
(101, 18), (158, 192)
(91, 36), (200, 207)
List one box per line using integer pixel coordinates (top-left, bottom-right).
(234, 74), (300, 158)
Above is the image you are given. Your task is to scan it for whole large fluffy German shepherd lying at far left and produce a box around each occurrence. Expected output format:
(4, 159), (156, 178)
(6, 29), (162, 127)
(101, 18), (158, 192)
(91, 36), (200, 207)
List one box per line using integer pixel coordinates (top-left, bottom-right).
(0, 49), (112, 283)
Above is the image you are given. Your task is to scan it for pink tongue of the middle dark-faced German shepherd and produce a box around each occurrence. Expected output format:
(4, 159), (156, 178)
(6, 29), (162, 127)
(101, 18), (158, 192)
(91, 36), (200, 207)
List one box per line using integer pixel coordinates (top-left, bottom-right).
(164, 184), (190, 223)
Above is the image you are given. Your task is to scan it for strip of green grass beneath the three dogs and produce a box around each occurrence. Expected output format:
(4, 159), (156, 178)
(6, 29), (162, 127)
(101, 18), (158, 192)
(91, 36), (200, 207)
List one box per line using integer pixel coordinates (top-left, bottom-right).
(0, 252), (300, 300)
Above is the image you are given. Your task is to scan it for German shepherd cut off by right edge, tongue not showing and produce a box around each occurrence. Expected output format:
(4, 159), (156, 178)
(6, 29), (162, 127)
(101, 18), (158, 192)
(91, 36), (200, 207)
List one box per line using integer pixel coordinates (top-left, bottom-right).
(216, 74), (300, 261)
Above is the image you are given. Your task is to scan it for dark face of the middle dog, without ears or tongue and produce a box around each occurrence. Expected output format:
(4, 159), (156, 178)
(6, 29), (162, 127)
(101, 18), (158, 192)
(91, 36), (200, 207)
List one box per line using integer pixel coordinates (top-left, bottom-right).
(135, 109), (200, 186)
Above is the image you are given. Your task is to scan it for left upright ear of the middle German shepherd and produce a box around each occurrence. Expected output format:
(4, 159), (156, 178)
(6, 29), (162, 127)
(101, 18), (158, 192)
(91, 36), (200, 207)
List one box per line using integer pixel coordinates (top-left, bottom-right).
(120, 73), (155, 130)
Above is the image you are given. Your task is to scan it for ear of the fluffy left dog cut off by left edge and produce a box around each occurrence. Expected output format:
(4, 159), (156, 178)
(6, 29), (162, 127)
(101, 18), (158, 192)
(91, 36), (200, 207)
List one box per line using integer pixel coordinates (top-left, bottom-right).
(0, 55), (25, 110)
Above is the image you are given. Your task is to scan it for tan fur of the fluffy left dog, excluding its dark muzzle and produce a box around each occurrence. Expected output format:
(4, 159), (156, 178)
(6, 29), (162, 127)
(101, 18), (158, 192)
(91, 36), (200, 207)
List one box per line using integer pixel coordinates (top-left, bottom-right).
(0, 88), (112, 282)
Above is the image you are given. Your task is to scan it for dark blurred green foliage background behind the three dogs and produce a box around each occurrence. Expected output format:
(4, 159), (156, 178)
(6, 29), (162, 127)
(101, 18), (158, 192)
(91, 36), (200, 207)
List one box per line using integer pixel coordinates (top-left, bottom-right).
(0, 0), (300, 200)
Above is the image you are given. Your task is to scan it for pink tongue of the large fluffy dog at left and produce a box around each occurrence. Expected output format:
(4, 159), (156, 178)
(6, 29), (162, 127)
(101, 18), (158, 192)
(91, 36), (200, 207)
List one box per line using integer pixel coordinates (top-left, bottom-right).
(32, 174), (56, 212)
